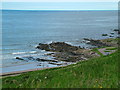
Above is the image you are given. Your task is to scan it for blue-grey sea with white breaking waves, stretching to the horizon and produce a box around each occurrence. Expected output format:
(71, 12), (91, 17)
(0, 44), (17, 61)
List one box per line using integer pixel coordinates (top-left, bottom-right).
(0, 10), (118, 72)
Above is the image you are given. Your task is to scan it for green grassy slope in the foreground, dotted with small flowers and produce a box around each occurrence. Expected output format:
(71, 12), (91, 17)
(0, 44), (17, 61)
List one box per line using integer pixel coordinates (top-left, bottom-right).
(3, 52), (118, 88)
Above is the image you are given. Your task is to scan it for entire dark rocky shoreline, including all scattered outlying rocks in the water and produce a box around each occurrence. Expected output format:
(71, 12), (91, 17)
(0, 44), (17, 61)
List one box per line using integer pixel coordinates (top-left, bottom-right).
(16, 29), (120, 65)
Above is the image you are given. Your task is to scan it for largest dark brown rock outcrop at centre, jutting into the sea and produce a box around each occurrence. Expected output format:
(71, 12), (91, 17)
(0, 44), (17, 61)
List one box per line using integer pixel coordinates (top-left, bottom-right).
(36, 42), (97, 62)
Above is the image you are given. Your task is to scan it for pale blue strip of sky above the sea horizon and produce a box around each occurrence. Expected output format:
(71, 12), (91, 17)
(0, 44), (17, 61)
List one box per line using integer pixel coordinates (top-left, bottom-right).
(1, 0), (119, 10)
